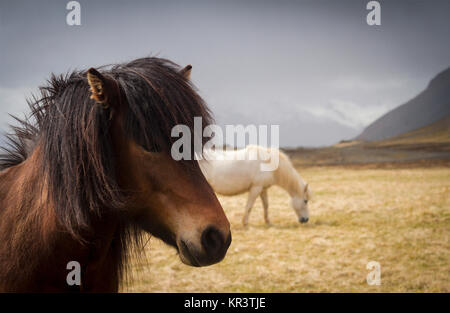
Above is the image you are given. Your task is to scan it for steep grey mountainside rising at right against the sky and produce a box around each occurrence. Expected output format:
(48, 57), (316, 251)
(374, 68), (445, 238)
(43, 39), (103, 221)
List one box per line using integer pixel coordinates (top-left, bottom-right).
(355, 68), (450, 141)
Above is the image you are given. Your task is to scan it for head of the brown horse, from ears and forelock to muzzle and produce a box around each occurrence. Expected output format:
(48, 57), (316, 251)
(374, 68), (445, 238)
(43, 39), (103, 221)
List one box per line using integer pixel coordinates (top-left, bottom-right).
(86, 60), (231, 266)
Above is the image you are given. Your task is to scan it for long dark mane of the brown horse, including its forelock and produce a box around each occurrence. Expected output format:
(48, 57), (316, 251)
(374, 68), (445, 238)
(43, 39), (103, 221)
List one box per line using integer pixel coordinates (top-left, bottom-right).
(0, 57), (212, 239)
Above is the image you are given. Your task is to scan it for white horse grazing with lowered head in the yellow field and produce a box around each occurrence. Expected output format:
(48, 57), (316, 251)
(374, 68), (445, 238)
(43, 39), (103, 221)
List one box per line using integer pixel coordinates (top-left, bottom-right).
(199, 146), (311, 226)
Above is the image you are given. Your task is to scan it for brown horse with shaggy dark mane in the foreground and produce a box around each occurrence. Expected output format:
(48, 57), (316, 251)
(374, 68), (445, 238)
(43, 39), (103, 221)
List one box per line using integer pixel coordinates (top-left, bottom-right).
(0, 58), (231, 292)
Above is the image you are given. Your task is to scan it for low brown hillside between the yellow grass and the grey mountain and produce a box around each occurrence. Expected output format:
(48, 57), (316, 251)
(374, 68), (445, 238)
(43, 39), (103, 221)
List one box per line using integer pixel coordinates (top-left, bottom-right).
(283, 115), (450, 167)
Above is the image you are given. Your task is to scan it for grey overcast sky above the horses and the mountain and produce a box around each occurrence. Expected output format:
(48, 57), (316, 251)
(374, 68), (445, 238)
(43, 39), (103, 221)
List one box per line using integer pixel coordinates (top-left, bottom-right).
(0, 0), (450, 146)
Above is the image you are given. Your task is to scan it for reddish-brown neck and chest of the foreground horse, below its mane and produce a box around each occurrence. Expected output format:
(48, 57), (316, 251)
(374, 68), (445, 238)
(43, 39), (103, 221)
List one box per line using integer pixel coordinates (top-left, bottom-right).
(0, 146), (123, 292)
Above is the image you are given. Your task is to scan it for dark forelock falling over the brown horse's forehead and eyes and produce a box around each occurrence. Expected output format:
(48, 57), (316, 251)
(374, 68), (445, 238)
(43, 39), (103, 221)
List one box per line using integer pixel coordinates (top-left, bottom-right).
(111, 58), (211, 164)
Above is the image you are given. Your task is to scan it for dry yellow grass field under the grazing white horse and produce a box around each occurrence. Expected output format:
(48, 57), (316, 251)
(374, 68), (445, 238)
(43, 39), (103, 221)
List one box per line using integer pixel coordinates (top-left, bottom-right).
(122, 167), (450, 292)
